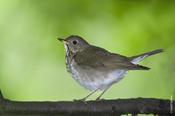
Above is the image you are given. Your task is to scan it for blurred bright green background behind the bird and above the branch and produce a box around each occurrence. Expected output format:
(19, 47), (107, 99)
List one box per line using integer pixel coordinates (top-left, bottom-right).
(0, 0), (175, 101)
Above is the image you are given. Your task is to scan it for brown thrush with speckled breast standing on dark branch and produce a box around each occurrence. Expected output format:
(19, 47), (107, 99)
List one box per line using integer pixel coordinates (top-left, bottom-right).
(58, 35), (163, 101)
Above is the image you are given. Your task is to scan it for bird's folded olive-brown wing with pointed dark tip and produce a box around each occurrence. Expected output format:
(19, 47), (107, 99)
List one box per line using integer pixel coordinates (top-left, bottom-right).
(74, 46), (149, 70)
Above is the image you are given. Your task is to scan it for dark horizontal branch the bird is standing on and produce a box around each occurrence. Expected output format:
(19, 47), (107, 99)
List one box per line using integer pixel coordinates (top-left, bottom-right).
(0, 93), (175, 116)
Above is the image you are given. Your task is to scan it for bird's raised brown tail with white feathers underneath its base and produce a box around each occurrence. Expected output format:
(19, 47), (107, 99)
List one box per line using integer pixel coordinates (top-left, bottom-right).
(129, 49), (163, 64)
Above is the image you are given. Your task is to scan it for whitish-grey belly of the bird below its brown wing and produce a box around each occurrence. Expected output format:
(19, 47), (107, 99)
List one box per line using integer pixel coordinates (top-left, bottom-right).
(71, 60), (127, 90)
